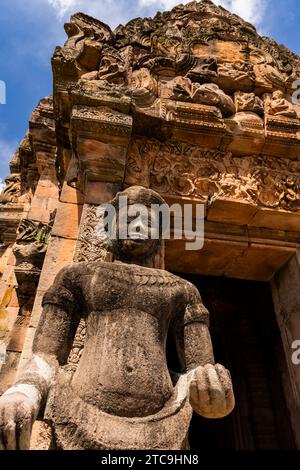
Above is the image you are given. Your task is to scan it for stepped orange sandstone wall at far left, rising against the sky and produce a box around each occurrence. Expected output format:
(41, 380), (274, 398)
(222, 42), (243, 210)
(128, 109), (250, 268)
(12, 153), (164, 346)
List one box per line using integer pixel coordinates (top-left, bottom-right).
(0, 97), (59, 393)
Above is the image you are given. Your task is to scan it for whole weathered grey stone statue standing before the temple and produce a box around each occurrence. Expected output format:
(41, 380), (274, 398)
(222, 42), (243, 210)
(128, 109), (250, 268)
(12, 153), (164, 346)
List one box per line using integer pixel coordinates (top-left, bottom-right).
(0, 187), (234, 449)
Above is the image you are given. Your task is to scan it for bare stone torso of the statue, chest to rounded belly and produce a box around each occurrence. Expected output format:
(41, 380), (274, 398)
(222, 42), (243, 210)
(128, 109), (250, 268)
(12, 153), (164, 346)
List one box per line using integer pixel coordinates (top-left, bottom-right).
(72, 262), (185, 416)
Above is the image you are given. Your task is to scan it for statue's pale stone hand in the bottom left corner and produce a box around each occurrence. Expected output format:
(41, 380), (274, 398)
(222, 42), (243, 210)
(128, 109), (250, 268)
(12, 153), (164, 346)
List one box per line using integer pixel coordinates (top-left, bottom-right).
(0, 392), (36, 450)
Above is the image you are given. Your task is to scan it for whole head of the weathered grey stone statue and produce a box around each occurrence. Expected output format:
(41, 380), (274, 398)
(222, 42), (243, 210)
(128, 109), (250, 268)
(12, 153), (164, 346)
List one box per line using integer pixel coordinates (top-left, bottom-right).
(112, 186), (165, 262)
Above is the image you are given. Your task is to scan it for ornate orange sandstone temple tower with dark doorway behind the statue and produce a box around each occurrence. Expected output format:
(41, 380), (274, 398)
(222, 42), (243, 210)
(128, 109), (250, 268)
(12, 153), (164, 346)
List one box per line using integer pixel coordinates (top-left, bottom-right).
(0, 0), (300, 449)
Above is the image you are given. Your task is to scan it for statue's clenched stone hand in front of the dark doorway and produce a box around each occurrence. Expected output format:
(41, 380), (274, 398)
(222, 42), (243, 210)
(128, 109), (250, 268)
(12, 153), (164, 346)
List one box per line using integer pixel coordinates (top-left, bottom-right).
(188, 364), (235, 418)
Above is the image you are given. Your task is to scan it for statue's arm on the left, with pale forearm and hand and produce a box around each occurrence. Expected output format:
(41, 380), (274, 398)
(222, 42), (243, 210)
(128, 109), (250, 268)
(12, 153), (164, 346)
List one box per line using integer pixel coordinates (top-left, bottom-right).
(0, 269), (80, 450)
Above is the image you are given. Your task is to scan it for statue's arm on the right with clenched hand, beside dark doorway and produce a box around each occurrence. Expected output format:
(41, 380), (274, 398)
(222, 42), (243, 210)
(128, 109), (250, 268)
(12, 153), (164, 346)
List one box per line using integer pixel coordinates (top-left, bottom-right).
(183, 283), (235, 418)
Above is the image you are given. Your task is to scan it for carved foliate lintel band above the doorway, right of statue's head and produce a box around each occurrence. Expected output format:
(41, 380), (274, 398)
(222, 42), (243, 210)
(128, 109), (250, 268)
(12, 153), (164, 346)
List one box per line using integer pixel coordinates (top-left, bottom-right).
(125, 139), (300, 212)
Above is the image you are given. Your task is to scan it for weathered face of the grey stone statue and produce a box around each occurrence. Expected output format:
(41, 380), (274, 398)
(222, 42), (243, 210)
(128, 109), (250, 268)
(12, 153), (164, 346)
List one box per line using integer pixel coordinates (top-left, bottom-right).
(117, 204), (160, 259)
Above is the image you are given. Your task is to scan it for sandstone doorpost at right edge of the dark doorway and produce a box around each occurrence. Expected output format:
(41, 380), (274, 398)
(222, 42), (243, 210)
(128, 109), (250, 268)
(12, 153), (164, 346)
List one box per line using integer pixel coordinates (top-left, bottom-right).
(271, 250), (300, 449)
